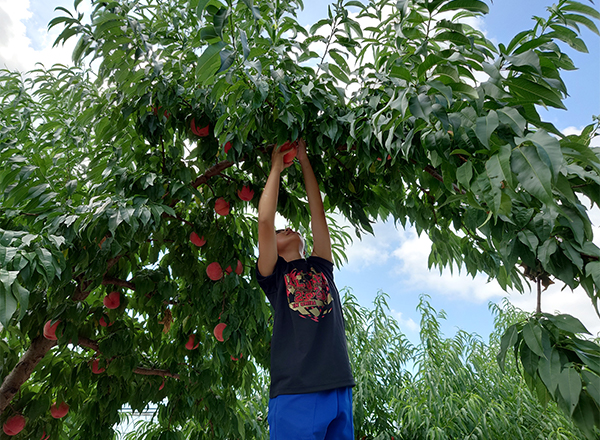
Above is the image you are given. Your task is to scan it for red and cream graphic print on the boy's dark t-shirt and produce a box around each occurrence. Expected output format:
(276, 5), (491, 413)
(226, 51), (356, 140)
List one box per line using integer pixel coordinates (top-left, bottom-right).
(285, 267), (333, 322)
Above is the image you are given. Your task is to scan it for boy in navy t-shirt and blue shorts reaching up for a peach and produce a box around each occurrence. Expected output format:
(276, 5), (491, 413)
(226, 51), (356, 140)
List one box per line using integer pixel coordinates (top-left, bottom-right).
(257, 139), (355, 440)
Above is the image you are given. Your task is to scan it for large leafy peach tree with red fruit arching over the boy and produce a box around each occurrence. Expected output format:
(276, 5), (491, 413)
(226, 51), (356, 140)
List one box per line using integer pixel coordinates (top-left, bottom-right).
(0, 0), (600, 438)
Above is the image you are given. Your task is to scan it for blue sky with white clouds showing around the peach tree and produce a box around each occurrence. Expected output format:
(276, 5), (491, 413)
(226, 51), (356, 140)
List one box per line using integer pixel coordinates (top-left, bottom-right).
(0, 0), (600, 342)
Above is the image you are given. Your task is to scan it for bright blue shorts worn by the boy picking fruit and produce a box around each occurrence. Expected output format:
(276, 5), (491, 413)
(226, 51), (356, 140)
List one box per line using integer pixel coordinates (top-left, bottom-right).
(268, 387), (354, 440)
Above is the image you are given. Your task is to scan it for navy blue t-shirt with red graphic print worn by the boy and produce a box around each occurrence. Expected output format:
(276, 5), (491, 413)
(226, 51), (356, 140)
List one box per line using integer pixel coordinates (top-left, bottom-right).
(256, 256), (355, 398)
